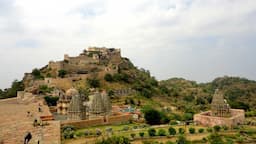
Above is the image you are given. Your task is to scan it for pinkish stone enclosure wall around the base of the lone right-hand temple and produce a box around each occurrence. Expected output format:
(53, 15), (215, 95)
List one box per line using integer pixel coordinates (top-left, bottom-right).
(194, 109), (245, 127)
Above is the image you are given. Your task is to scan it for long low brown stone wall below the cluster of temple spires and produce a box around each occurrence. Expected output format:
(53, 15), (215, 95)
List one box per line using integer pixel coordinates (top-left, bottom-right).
(61, 114), (132, 128)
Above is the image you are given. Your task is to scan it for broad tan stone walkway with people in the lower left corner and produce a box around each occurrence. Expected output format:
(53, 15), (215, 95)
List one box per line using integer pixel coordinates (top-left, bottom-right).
(0, 98), (61, 144)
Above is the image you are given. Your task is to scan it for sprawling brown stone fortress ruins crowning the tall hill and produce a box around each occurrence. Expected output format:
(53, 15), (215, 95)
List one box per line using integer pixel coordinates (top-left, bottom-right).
(23, 47), (122, 94)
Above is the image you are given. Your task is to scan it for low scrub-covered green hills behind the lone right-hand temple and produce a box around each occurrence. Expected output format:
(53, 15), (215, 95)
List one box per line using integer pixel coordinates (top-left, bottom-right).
(160, 76), (256, 110)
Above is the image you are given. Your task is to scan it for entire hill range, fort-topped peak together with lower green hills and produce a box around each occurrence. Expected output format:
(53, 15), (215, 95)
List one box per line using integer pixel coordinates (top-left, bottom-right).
(0, 47), (256, 113)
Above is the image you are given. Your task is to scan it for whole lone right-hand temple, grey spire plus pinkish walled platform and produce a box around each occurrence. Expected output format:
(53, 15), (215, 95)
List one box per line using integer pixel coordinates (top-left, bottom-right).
(194, 90), (245, 127)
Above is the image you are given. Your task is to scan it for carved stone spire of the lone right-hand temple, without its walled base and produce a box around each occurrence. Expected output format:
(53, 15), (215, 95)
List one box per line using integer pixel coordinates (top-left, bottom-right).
(211, 89), (230, 117)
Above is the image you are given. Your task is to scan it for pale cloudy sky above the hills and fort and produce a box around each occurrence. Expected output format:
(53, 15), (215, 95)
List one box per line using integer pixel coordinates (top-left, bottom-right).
(0, 0), (256, 88)
